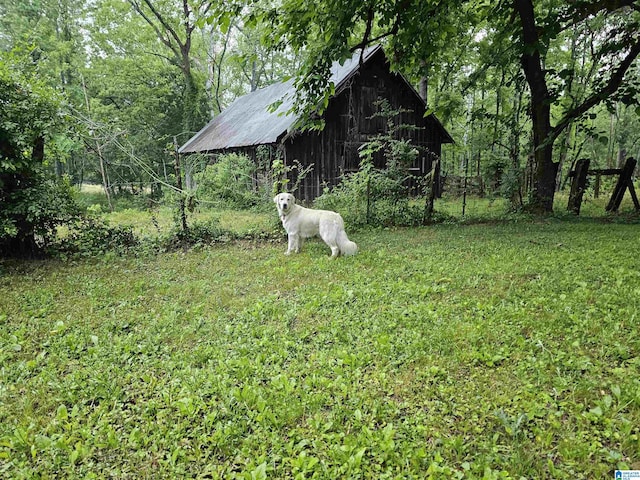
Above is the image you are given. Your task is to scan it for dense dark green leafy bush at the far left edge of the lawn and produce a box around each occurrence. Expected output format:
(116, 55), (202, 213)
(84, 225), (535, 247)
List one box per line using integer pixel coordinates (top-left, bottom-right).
(0, 53), (77, 256)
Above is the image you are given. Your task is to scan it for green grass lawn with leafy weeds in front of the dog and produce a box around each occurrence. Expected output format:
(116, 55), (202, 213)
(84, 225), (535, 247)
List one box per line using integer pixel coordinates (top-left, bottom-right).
(0, 219), (640, 479)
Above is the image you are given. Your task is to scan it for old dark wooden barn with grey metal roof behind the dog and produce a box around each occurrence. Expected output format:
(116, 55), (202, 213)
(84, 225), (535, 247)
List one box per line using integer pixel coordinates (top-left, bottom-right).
(179, 46), (453, 201)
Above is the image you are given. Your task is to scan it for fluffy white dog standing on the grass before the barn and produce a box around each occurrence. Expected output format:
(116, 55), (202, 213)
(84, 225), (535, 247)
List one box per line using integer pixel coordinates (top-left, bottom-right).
(273, 193), (358, 258)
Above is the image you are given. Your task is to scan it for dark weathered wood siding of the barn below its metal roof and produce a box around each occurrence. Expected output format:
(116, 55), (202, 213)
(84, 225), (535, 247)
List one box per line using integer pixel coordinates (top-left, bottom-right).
(284, 51), (445, 201)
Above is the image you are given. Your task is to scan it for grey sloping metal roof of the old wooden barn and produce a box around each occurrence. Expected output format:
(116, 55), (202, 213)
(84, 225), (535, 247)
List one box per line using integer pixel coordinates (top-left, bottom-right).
(179, 46), (382, 153)
